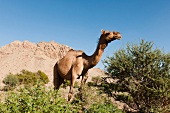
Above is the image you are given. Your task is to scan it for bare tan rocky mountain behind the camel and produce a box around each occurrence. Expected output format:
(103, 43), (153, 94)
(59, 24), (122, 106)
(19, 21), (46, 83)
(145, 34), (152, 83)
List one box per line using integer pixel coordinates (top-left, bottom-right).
(0, 41), (104, 86)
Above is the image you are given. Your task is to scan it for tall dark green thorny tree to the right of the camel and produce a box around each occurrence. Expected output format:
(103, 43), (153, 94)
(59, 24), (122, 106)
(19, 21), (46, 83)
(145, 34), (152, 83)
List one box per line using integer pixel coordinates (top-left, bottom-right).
(103, 40), (170, 112)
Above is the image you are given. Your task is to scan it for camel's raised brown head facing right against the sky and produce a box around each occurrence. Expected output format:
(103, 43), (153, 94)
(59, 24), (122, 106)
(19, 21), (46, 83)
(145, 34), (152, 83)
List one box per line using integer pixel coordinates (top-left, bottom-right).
(101, 30), (122, 43)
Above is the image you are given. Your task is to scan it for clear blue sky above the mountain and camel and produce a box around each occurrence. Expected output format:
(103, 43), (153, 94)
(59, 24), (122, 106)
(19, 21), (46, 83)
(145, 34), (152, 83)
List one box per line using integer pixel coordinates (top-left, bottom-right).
(0, 0), (170, 68)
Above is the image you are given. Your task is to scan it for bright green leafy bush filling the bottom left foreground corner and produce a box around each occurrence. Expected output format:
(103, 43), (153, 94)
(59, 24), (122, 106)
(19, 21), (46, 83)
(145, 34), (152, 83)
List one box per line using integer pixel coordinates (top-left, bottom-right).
(0, 85), (79, 113)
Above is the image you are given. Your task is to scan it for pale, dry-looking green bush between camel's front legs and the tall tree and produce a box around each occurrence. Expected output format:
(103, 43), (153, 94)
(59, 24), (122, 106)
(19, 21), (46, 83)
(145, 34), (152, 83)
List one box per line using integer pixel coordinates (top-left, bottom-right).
(72, 85), (123, 113)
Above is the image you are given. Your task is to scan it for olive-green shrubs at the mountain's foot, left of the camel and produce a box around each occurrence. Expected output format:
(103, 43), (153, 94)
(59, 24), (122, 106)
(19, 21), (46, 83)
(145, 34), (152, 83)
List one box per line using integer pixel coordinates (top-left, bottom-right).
(3, 70), (49, 91)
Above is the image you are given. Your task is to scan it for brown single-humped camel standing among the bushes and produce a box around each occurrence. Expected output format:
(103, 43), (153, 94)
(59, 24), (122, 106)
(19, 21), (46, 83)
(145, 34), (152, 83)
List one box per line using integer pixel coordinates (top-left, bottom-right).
(53, 30), (122, 101)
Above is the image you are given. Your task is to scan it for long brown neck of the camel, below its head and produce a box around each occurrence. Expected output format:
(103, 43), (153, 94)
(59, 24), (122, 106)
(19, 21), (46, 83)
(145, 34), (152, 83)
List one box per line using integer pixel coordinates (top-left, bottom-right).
(89, 42), (107, 67)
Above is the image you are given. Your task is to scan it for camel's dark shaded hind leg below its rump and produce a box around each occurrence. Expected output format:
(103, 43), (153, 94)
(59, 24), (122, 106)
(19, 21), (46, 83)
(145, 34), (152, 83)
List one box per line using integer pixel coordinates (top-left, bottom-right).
(53, 63), (64, 90)
